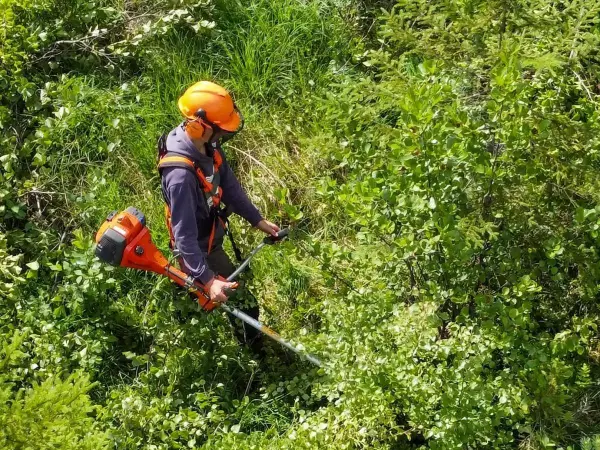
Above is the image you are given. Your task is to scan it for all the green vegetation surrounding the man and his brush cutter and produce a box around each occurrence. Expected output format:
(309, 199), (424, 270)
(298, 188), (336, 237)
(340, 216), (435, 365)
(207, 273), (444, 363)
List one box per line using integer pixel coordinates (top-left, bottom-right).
(0, 0), (600, 450)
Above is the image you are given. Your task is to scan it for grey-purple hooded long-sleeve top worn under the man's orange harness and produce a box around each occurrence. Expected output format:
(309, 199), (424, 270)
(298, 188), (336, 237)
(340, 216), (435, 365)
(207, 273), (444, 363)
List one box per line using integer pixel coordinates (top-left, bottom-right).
(161, 124), (262, 284)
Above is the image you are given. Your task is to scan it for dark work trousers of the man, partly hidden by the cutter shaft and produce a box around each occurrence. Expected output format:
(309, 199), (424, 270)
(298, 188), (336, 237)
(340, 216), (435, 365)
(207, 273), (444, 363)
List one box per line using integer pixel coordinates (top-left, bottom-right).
(207, 245), (262, 354)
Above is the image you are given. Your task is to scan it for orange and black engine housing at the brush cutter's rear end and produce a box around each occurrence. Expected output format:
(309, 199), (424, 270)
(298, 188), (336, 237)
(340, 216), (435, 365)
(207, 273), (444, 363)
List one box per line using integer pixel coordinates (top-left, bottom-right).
(96, 207), (169, 275)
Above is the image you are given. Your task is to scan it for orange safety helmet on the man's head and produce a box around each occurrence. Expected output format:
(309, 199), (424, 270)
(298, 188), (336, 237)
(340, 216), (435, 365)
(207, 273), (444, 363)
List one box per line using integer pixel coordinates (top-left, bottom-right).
(178, 81), (243, 133)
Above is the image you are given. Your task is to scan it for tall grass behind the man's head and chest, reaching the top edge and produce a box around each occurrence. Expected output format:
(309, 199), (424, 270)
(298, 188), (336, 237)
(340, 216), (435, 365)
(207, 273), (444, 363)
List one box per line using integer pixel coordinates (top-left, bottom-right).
(129, 0), (348, 246)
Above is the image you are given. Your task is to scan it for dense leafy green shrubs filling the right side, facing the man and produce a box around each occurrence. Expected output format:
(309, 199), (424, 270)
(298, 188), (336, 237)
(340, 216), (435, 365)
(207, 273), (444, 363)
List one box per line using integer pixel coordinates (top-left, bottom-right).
(292, 1), (600, 449)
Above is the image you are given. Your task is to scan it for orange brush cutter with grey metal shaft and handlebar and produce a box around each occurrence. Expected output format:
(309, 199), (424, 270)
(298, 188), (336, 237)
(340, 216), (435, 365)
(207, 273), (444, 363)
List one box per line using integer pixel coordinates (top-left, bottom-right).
(96, 207), (321, 367)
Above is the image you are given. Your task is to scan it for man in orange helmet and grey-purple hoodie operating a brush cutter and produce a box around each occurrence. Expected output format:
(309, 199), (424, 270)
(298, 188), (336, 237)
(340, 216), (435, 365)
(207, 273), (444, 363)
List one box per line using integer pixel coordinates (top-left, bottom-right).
(159, 81), (279, 352)
